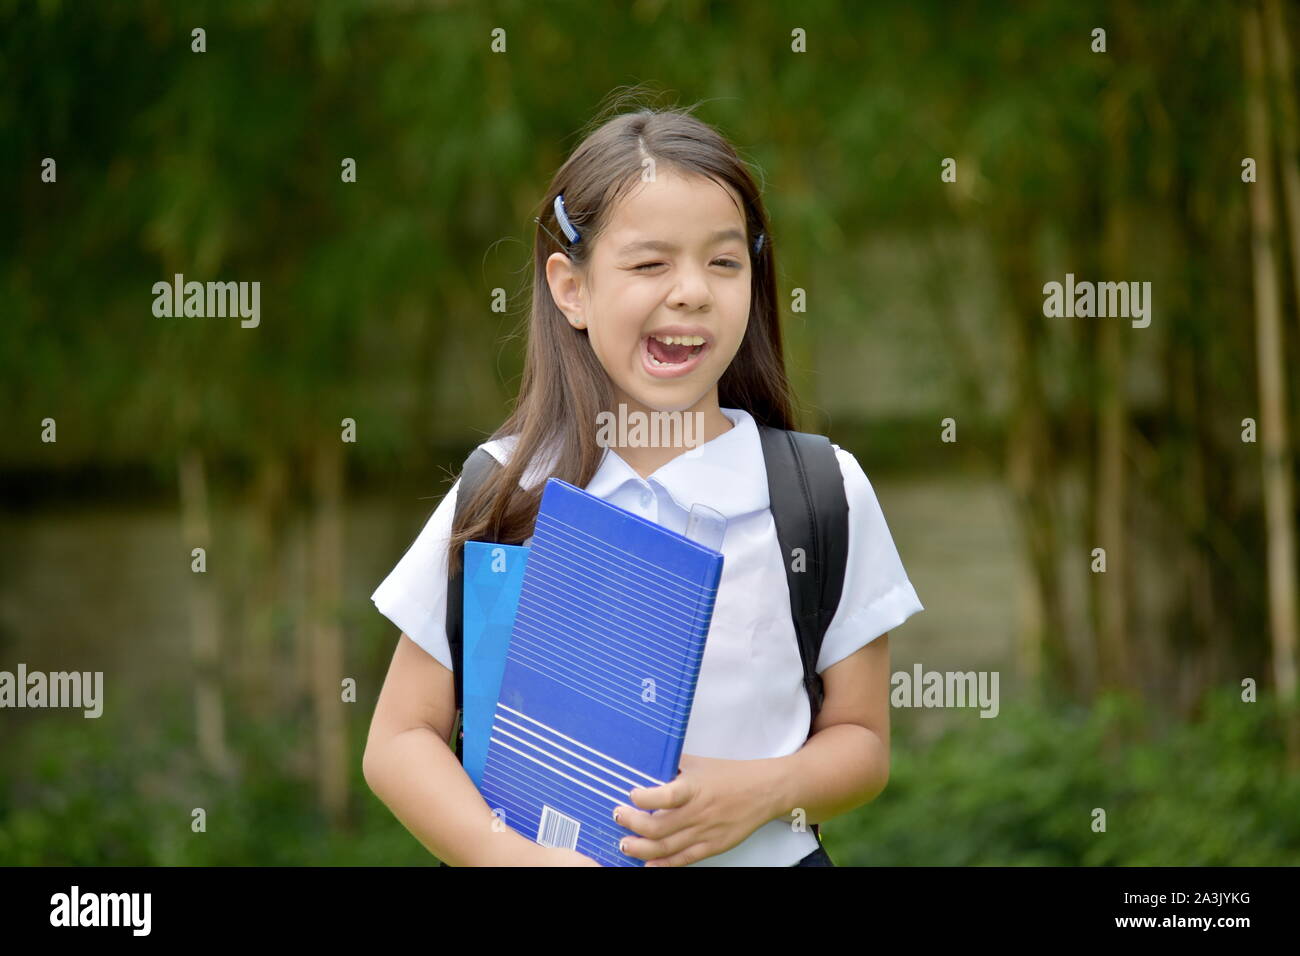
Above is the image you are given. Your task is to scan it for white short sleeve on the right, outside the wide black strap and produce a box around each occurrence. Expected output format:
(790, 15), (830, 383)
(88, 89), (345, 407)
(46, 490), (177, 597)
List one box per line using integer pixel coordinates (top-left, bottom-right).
(816, 445), (926, 674)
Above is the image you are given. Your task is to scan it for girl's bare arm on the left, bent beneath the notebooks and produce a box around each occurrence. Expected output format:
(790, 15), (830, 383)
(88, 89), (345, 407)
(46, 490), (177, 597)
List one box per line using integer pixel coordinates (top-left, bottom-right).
(361, 633), (599, 866)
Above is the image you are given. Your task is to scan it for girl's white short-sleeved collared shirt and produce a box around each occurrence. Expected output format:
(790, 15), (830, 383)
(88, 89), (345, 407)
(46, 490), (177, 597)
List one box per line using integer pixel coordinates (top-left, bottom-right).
(371, 408), (924, 866)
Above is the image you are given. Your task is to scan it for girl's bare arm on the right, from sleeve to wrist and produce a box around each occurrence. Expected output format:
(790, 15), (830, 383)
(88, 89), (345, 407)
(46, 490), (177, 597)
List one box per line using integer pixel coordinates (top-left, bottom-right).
(770, 633), (889, 826)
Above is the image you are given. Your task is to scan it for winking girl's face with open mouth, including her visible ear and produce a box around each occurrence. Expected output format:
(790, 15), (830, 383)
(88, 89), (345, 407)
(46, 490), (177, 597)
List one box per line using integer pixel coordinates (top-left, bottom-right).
(546, 170), (751, 421)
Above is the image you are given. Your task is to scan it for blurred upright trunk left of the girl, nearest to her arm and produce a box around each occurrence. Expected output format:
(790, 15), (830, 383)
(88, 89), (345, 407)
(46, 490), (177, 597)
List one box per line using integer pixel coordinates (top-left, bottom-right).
(309, 436), (348, 826)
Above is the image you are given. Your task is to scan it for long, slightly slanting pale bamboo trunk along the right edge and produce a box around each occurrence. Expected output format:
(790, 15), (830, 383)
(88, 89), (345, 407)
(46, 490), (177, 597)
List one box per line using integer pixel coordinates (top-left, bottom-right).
(1243, 4), (1300, 766)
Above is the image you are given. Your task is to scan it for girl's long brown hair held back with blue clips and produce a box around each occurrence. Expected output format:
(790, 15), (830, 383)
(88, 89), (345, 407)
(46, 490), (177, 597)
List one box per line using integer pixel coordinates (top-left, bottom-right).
(449, 98), (794, 572)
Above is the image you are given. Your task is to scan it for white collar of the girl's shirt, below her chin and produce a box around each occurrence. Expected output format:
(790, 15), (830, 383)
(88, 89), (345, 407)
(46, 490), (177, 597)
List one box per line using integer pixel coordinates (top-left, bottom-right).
(586, 408), (770, 519)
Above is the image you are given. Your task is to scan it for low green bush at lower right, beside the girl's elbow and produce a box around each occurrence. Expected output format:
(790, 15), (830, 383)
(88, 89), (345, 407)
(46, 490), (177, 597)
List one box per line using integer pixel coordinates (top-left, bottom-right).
(823, 689), (1300, 866)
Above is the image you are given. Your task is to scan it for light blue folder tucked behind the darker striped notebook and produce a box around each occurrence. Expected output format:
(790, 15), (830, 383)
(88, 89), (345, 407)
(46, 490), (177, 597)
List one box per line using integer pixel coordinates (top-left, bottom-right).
(462, 541), (528, 788)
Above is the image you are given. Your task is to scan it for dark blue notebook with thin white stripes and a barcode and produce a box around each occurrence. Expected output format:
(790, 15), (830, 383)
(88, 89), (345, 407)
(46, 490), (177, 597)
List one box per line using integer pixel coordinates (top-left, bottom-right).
(478, 477), (723, 866)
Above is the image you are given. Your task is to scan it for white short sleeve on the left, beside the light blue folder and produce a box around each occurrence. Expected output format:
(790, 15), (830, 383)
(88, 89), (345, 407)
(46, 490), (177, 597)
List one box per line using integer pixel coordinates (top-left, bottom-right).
(371, 479), (460, 671)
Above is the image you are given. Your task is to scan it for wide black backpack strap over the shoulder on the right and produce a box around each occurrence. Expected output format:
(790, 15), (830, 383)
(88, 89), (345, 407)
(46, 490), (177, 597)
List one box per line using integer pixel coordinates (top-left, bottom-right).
(758, 425), (849, 840)
